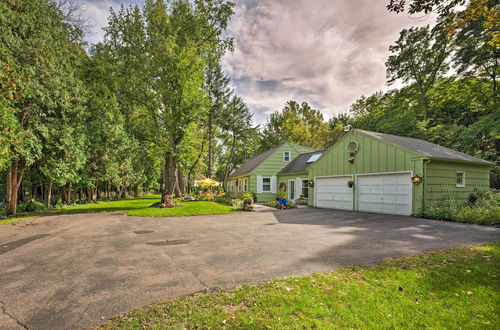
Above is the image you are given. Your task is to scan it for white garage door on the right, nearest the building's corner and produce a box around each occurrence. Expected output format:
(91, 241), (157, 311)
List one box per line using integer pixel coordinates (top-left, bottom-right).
(356, 173), (412, 215)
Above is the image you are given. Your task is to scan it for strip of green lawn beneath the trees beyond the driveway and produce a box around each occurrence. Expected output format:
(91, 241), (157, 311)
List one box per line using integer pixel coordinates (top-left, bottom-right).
(0, 195), (234, 224)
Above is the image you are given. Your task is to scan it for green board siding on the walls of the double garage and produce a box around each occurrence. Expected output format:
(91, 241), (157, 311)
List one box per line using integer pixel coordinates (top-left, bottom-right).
(308, 131), (490, 214)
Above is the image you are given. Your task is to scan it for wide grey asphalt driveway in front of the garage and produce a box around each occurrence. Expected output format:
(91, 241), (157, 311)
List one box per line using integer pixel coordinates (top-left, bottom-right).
(0, 209), (500, 329)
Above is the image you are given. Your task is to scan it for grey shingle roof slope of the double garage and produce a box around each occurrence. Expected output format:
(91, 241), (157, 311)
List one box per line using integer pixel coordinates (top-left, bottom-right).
(355, 129), (491, 164)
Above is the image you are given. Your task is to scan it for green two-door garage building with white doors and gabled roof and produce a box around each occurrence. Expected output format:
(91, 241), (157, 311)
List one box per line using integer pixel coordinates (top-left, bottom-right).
(307, 129), (492, 215)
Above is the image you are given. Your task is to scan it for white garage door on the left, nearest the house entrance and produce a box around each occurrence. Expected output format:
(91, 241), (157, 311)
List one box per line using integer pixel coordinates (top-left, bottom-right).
(315, 176), (353, 210)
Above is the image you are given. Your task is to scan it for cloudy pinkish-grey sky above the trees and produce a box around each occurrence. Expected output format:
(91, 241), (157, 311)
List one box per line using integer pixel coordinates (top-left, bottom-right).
(82, 0), (433, 123)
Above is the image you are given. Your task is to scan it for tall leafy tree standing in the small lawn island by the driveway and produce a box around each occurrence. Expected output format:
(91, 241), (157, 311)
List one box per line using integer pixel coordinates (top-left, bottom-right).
(105, 0), (233, 193)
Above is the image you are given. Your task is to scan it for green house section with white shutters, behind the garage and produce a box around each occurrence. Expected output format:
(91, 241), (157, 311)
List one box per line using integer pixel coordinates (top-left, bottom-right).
(225, 142), (316, 202)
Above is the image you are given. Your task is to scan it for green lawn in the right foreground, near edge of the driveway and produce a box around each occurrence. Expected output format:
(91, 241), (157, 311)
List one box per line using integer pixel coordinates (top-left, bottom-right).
(104, 243), (500, 329)
